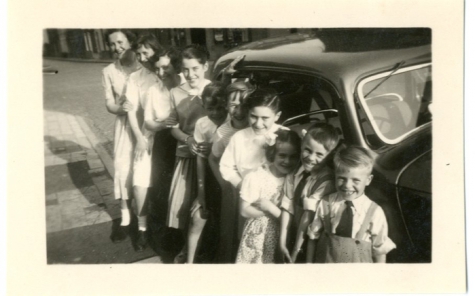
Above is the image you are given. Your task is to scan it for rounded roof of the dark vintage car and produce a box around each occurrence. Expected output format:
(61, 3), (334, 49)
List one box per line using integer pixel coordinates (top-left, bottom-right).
(215, 34), (431, 82)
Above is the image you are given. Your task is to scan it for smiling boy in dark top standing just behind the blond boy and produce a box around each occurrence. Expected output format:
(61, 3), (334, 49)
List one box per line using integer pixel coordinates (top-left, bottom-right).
(279, 124), (340, 263)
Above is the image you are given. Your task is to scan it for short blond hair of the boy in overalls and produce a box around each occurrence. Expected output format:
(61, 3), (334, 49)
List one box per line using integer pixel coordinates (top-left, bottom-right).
(333, 146), (374, 173)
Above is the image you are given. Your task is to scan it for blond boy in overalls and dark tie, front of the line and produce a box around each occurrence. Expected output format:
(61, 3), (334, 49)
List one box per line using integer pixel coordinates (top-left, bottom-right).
(307, 147), (396, 263)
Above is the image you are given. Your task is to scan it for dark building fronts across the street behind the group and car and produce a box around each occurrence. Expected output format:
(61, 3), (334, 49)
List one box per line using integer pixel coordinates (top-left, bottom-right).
(43, 28), (431, 60)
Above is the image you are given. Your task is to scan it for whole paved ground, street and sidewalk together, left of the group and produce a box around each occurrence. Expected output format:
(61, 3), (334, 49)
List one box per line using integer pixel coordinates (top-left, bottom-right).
(43, 61), (169, 264)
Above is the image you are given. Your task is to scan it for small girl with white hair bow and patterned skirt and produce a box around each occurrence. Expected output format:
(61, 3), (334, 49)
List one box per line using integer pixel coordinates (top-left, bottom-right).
(236, 130), (300, 263)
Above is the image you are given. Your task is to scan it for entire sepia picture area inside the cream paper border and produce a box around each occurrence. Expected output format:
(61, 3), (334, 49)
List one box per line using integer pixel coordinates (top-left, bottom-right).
(43, 28), (432, 264)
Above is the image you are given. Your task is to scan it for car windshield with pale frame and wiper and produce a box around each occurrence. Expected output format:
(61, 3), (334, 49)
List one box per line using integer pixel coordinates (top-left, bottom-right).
(358, 64), (432, 144)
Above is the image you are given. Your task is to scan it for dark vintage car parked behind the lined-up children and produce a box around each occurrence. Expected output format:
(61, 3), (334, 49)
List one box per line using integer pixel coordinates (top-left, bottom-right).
(213, 35), (432, 263)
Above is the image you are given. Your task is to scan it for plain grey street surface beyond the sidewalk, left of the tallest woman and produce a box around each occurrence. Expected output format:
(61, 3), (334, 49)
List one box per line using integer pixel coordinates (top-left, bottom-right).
(43, 60), (115, 155)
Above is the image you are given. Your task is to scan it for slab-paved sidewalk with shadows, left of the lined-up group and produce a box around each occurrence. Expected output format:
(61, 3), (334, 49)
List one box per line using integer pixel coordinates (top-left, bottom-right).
(44, 110), (160, 264)
